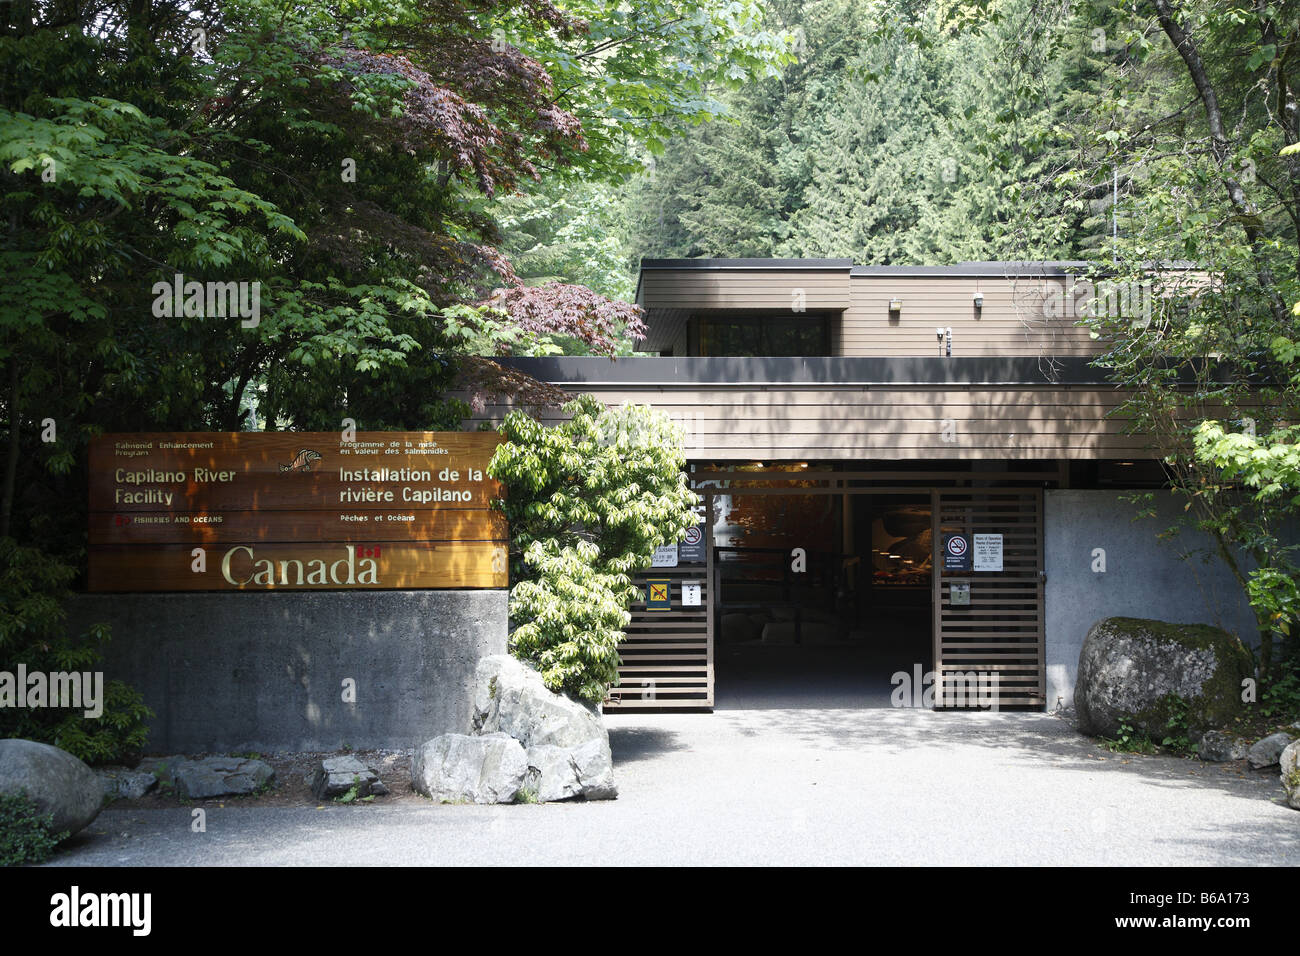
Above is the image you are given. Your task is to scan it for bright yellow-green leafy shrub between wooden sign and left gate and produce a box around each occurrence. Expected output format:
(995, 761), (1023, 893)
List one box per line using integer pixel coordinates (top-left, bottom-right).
(489, 395), (698, 702)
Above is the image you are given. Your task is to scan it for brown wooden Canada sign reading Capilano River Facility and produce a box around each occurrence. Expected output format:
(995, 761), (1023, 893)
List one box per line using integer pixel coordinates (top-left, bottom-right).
(88, 432), (508, 591)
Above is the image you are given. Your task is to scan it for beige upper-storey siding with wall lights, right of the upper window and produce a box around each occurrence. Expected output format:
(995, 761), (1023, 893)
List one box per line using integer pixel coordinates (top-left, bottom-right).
(839, 276), (1100, 356)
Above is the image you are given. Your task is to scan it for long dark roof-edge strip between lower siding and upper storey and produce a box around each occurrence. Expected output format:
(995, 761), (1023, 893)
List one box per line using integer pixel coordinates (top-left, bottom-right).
(498, 356), (1128, 388)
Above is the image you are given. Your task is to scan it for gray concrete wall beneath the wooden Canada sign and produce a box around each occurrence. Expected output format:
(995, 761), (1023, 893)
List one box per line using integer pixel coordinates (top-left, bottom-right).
(69, 591), (507, 753)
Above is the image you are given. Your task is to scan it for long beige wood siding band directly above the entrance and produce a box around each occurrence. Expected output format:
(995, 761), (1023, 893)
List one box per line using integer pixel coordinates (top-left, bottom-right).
(467, 386), (1148, 460)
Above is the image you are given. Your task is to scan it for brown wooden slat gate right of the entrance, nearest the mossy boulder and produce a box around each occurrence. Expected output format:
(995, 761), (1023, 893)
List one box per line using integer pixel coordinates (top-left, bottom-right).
(931, 488), (1047, 708)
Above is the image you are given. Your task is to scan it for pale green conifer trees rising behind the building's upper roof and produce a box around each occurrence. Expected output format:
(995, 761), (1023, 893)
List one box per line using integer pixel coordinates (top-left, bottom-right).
(627, 0), (1109, 264)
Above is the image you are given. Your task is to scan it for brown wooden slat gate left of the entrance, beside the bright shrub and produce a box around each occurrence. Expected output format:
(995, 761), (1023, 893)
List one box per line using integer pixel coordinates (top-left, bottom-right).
(605, 561), (714, 710)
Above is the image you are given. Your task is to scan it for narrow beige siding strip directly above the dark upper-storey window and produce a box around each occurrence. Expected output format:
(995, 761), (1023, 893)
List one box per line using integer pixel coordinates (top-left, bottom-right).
(638, 268), (849, 312)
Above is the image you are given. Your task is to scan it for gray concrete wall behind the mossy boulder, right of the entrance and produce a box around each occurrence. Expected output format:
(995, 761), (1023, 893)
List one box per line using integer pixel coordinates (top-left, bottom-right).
(1044, 490), (1258, 710)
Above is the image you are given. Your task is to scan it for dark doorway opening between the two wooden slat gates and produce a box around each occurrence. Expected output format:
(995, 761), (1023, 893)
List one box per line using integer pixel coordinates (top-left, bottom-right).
(712, 489), (933, 709)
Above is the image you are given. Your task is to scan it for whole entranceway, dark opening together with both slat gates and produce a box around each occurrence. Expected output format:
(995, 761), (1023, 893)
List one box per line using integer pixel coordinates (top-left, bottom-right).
(606, 462), (1060, 710)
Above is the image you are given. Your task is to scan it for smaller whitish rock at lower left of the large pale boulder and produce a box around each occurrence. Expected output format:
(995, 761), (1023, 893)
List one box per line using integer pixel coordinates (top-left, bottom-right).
(411, 734), (528, 804)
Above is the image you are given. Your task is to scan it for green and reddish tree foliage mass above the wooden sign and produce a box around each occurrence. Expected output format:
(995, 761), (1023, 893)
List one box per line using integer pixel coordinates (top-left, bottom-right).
(0, 0), (788, 582)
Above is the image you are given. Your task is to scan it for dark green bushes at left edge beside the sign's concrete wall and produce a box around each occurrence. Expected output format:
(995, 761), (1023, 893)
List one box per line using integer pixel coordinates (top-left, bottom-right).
(0, 538), (153, 763)
